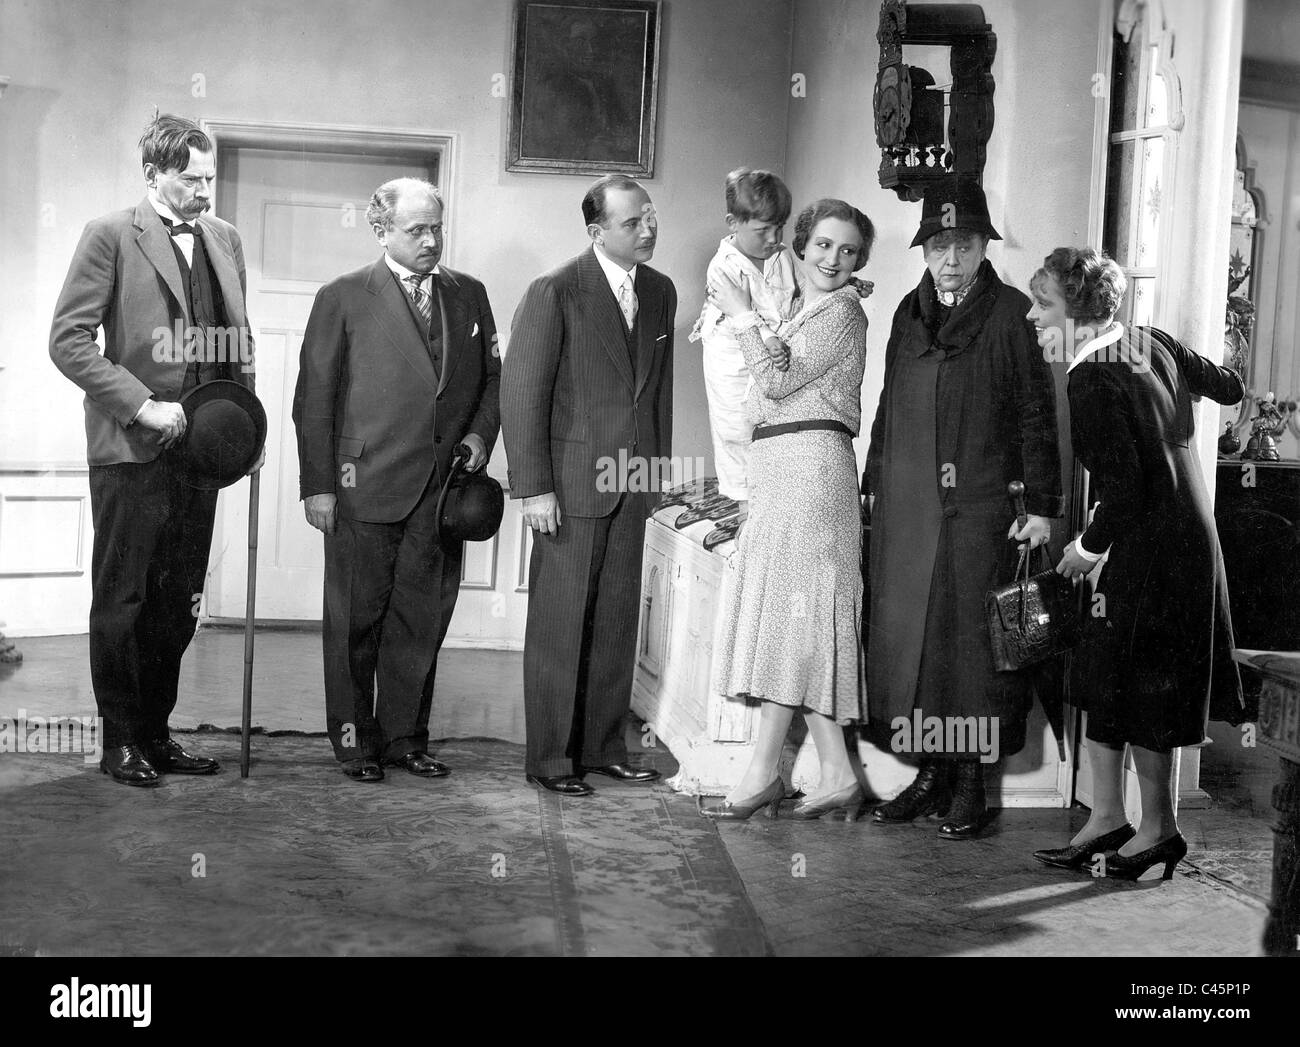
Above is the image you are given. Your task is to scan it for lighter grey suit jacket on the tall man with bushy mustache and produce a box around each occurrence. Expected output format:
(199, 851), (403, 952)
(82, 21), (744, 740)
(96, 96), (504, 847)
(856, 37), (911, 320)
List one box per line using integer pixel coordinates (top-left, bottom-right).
(49, 196), (254, 466)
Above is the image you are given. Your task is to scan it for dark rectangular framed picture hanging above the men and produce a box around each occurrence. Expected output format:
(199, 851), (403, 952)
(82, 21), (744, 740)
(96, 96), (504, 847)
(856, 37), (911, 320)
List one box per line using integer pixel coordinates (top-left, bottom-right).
(506, 0), (663, 177)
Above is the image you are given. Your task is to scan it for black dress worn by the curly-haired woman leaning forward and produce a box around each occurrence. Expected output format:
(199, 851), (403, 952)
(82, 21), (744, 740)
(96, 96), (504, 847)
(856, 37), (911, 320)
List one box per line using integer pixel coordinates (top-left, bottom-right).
(1069, 328), (1244, 750)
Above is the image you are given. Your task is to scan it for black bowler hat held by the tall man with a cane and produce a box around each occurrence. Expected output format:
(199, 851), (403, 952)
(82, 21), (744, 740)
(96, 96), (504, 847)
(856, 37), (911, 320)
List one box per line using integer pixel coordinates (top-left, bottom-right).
(172, 378), (267, 490)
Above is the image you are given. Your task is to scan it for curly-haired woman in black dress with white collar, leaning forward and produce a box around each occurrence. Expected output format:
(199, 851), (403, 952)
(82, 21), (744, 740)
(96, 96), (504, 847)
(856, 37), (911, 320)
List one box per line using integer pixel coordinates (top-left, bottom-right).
(1030, 247), (1244, 879)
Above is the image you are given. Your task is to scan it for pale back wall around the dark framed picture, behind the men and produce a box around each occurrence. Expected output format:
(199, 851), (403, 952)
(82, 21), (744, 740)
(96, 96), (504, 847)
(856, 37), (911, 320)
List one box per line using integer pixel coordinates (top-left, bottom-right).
(0, 0), (792, 633)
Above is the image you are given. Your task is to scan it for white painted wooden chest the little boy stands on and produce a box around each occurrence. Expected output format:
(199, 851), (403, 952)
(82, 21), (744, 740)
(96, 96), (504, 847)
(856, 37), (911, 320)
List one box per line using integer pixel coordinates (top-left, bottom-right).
(632, 506), (1074, 808)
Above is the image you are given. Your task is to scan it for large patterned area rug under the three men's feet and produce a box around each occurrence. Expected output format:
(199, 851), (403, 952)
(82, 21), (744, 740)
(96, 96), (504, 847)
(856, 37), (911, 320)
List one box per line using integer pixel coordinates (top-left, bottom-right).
(0, 732), (768, 956)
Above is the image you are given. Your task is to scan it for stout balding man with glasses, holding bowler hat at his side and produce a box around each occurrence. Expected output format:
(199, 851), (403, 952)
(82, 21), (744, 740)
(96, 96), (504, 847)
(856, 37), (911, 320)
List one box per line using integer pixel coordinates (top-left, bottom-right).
(294, 178), (501, 782)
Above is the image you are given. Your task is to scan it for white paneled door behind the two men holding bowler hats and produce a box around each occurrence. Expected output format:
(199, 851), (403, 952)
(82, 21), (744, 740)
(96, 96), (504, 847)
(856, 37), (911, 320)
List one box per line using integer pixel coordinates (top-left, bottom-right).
(202, 133), (527, 648)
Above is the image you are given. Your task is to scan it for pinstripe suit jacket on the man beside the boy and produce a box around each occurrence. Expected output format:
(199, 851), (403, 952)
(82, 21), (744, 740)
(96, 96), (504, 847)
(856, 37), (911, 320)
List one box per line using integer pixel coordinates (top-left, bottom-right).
(501, 248), (677, 525)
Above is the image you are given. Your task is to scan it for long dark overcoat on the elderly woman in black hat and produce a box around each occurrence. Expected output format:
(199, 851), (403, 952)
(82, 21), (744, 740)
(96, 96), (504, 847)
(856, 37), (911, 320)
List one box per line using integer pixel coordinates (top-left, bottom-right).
(863, 261), (1062, 756)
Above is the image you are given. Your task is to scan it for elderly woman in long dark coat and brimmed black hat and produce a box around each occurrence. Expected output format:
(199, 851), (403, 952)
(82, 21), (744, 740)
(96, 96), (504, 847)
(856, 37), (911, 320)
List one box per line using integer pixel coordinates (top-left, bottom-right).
(863, 178), (1062, 839)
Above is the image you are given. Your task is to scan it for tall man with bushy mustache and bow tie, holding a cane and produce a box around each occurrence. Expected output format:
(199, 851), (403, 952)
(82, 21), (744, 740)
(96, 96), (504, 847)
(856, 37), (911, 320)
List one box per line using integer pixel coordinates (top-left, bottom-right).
(49, 113), (261, 786)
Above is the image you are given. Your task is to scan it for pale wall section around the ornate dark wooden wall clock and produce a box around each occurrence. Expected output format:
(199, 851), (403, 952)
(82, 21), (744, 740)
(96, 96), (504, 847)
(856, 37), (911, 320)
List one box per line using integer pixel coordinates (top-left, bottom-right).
(774, 0), (1100, 492)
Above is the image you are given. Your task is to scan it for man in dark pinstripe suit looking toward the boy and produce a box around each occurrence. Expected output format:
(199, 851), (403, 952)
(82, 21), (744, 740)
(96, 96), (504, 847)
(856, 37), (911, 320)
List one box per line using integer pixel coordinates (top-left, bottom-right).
(501, 174), (677, 796)
